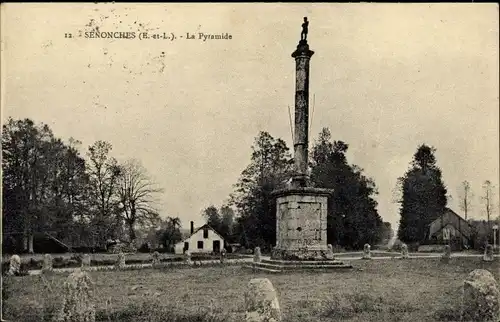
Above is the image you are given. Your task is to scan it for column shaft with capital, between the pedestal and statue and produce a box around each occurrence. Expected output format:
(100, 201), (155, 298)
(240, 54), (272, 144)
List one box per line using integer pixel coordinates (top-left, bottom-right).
(292, 40), (314, 188)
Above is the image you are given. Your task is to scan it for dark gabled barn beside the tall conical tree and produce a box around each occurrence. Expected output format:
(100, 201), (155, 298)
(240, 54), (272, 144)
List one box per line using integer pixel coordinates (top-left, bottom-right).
(429, 208), (473, 250)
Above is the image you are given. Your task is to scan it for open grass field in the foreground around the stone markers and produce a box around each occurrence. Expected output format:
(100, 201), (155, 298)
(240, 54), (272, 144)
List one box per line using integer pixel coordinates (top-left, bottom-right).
(4, 258), (500, 322)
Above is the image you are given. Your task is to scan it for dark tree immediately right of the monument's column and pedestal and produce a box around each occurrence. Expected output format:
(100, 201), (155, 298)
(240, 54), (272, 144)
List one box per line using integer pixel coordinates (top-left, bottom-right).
(311, 128), (382, 249)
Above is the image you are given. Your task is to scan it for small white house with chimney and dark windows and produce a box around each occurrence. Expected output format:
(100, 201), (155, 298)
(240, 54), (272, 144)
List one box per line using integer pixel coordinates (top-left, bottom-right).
(175, 222), (224, 254)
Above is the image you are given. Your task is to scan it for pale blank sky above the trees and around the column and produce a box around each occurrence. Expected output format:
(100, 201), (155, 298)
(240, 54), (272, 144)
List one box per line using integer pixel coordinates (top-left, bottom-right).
(1, 3), (500, 231)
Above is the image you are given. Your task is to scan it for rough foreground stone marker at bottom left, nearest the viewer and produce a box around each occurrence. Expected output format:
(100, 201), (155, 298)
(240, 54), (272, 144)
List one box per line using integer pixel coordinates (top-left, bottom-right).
(56, 269), (95, 322)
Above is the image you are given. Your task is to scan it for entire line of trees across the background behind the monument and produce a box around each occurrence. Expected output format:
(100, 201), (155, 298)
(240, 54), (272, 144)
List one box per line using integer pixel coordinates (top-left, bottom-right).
(2, 118), (498, 251)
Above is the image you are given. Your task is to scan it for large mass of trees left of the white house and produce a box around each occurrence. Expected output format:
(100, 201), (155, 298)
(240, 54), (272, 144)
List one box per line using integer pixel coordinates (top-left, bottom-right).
(2, 118), (162, 252)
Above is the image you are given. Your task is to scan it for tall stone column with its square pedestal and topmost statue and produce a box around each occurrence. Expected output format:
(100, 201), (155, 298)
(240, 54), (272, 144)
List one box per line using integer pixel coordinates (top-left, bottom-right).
(271, 17), (332, 260)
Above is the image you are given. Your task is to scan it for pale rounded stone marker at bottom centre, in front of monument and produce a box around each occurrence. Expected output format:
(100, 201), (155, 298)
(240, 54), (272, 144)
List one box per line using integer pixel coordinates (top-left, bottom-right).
(245, 278), (281, 322)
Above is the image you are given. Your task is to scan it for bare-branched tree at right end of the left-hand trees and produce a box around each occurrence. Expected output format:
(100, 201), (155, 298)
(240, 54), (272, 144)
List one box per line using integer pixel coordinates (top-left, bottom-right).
(117, 160), (162, 242)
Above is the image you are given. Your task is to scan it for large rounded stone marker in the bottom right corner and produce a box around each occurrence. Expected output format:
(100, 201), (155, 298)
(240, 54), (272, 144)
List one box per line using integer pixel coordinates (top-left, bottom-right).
(462, 269), (500, 322)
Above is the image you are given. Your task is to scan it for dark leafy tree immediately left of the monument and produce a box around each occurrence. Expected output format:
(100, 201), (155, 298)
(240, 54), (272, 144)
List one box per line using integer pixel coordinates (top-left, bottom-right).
(230, 132), (293, 248)
